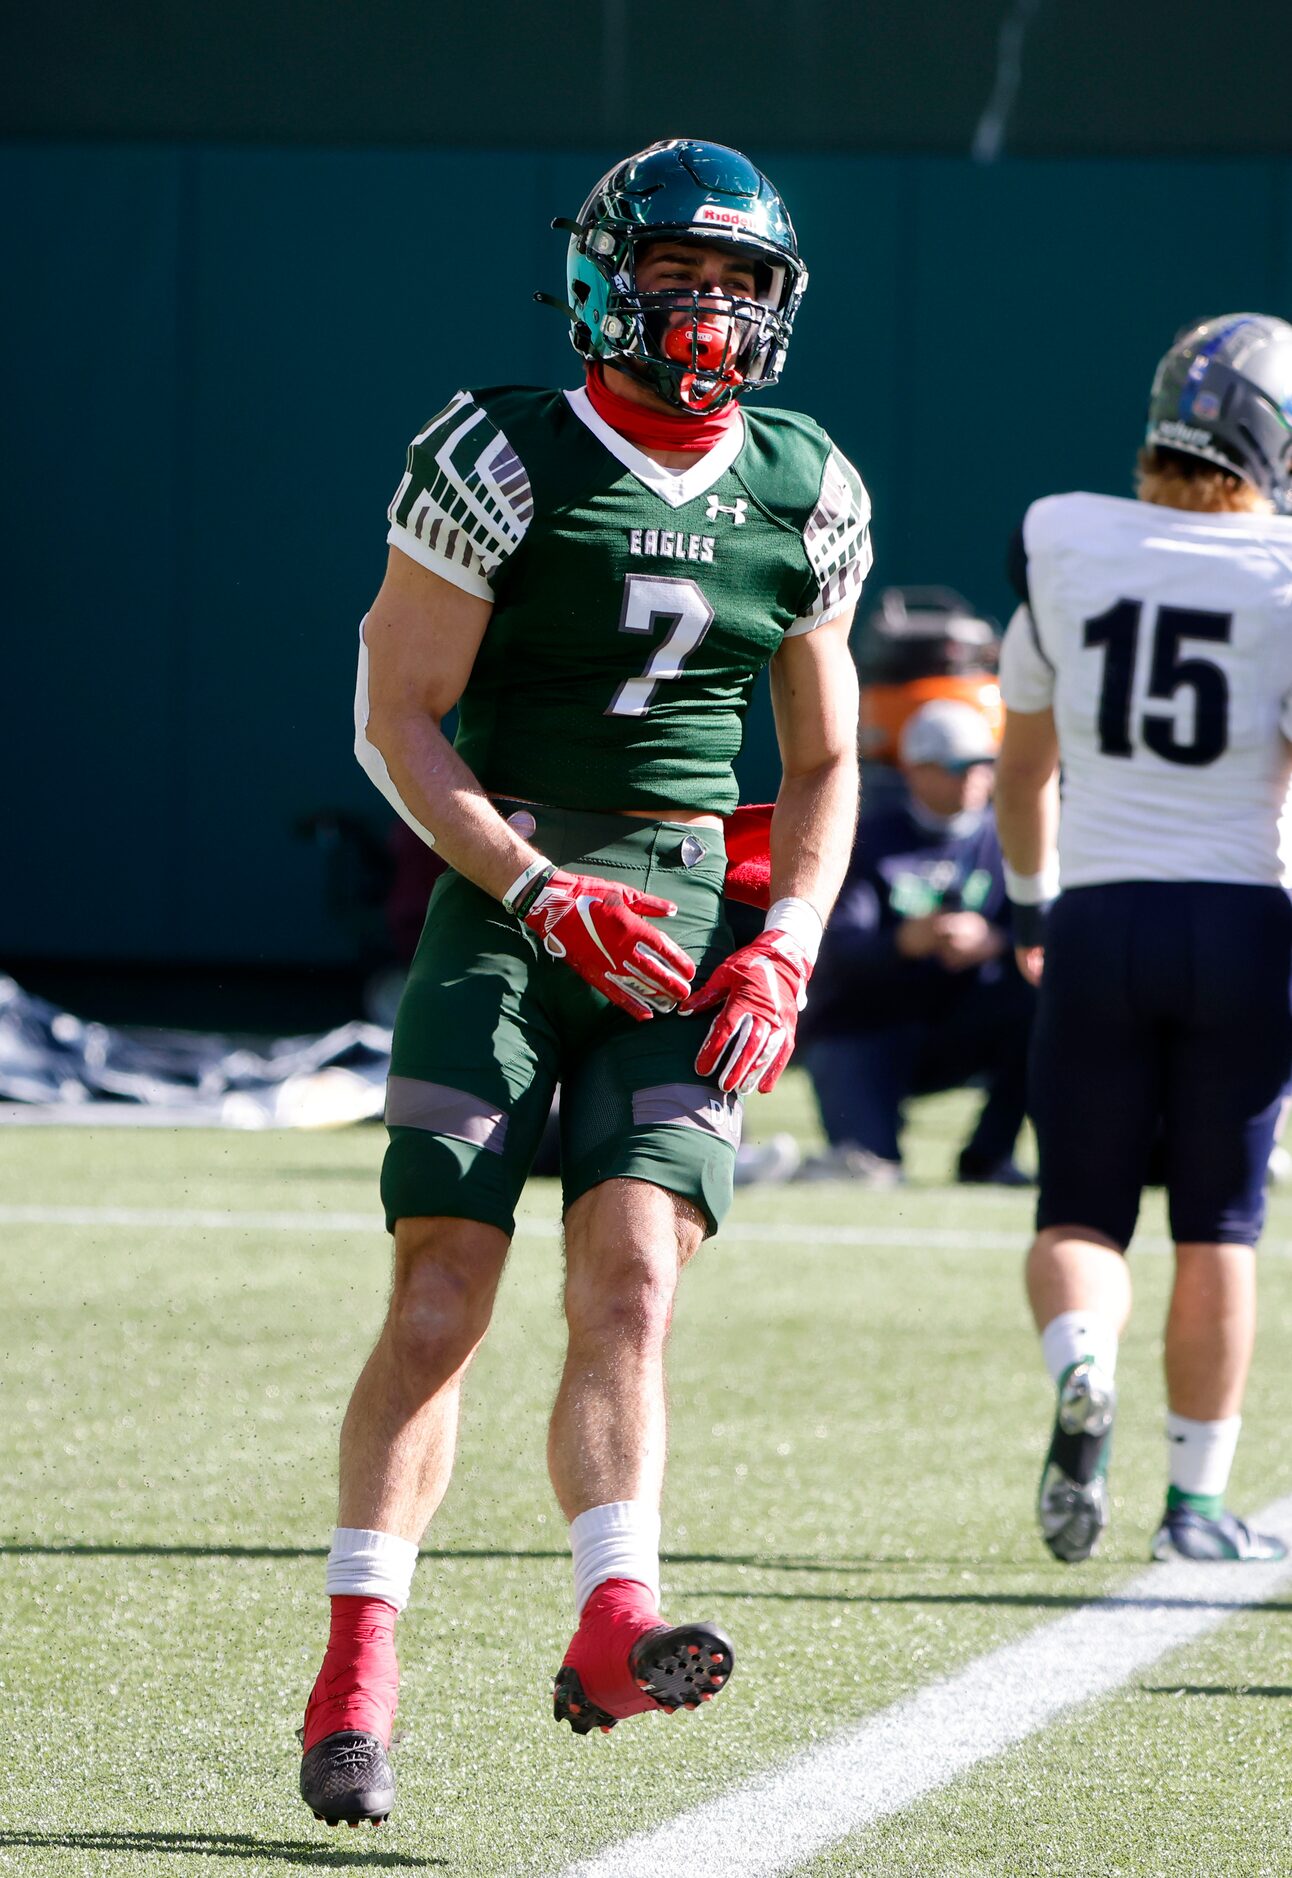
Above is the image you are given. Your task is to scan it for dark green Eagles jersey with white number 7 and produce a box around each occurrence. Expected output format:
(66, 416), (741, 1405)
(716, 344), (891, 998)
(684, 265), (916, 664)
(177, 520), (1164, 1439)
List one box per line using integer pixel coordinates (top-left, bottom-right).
(389, 387), (871, 813)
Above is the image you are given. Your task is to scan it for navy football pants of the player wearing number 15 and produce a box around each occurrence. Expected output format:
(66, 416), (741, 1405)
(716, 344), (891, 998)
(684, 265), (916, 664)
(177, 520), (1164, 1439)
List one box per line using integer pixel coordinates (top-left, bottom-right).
(1029, 881), (1292, 1249)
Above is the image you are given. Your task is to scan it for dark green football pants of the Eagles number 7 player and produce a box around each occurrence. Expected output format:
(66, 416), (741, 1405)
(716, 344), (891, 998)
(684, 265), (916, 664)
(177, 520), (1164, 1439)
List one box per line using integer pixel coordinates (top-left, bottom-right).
(381, 804), (740, 1234)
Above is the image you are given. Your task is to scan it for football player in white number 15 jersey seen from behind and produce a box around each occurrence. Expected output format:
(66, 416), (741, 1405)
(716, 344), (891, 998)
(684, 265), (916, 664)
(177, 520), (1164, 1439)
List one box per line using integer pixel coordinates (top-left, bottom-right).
(995, 314), (1292, 1562)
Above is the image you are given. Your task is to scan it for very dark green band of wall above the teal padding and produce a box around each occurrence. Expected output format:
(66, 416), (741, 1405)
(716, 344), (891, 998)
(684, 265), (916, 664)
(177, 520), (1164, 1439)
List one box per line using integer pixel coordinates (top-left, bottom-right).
(0, 0), (1292, 156)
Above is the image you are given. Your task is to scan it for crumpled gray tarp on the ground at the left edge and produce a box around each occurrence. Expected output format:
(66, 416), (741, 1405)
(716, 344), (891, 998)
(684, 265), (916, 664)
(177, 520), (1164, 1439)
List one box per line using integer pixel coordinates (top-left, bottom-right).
(0, 977), (391, 1129)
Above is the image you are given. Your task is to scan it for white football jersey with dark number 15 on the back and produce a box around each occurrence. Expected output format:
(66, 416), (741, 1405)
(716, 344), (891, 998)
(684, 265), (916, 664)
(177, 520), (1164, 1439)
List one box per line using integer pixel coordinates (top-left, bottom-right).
(1001, 494), (1292, 886)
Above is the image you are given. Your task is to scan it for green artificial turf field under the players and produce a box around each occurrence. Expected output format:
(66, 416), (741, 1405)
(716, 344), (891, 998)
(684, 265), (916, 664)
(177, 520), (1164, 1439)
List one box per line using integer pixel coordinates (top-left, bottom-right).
(0, 1076), (1292, 1878)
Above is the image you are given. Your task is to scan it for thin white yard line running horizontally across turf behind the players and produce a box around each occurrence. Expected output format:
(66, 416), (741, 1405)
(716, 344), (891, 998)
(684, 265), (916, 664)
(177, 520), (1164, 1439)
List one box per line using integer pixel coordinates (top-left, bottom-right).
(0, 1206), (1292, 1258)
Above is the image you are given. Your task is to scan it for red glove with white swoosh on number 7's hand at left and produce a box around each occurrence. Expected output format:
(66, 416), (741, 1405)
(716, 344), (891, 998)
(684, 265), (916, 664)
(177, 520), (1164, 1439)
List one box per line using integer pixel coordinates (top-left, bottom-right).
(520, 868), (695, 1024)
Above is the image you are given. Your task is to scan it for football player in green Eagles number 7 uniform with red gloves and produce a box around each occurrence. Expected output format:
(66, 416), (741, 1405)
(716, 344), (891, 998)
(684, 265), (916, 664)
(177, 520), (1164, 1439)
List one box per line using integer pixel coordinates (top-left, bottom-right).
(300, 141), (869, 1822)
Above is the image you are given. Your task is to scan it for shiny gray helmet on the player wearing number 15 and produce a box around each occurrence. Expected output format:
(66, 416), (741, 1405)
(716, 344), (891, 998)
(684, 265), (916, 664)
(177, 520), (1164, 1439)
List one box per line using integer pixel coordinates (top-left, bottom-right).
(1146, 314), (1292, 515)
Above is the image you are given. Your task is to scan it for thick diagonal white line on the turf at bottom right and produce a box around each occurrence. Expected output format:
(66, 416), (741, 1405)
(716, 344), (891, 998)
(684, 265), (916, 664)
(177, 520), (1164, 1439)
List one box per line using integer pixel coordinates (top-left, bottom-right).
(560, 1497), (1292, 1878)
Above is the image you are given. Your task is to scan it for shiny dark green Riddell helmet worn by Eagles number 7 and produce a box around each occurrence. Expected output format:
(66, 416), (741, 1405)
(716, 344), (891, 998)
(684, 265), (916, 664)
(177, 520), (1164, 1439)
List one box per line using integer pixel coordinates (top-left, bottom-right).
(552, 137), (808, 411)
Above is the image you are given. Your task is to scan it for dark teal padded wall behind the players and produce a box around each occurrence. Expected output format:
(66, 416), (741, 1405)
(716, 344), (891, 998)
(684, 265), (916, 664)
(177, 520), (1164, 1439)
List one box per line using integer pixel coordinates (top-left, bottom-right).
(0, 143), (1292, 962)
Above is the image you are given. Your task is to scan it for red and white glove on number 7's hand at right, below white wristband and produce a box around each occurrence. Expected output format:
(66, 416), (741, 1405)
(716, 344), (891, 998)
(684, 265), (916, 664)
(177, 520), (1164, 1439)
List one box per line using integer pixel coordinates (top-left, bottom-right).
(682, 928), (811, 1095)
